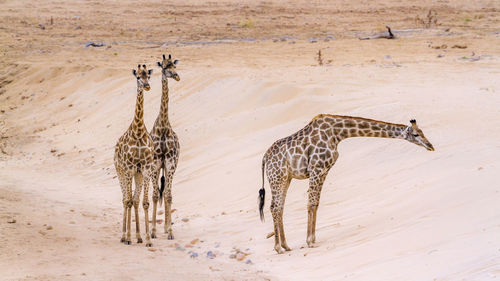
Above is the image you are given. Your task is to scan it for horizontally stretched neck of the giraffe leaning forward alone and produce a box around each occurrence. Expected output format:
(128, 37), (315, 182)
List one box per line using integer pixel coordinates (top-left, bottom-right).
(332, 116), (406, 141)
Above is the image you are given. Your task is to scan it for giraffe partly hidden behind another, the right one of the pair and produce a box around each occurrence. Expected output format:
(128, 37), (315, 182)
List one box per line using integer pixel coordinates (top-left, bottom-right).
(150, 55), (180, 240)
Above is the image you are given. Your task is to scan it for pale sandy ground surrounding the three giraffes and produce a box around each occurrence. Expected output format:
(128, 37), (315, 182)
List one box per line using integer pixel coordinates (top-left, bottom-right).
(0, 0), (500, 280)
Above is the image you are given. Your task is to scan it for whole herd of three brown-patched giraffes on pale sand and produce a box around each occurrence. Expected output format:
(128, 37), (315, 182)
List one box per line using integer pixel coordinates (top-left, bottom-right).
(114, 55), (434, 254)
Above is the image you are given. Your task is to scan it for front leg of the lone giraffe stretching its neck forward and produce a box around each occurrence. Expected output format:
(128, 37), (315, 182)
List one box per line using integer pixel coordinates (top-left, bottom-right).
(306, 171), (328, 248)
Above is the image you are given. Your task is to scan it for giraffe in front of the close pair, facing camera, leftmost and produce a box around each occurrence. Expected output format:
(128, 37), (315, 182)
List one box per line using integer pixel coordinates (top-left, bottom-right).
(114, 65), (154, 247)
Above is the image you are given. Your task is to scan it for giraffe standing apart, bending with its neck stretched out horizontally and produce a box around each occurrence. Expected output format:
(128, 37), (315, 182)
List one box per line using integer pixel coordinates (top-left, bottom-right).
(259, 114), (434, 254)
